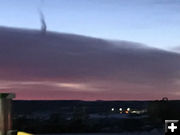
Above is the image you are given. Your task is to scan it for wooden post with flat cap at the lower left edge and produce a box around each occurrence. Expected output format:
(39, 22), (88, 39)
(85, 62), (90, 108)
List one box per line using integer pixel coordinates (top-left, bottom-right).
(0, 93), (15, 135)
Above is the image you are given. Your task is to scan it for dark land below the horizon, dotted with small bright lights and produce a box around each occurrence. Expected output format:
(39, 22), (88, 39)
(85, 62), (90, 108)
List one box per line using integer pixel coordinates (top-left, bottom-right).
(13, 101), (180, 135)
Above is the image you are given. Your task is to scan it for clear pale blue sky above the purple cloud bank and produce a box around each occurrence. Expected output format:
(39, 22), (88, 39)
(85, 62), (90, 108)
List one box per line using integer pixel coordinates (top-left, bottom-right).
(0, 0), (180, 49)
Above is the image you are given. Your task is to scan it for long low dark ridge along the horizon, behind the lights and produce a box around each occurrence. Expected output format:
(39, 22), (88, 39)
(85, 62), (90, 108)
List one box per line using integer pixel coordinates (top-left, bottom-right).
(13, 100), (149, 114)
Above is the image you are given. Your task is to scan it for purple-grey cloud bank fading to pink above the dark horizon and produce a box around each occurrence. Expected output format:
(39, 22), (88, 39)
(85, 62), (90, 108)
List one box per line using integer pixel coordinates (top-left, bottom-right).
(0, 27), (180, 100)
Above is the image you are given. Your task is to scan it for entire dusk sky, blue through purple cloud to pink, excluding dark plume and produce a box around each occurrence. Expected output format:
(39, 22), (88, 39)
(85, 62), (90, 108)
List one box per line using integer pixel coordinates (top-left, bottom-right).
(0, 0), (180, 100)
